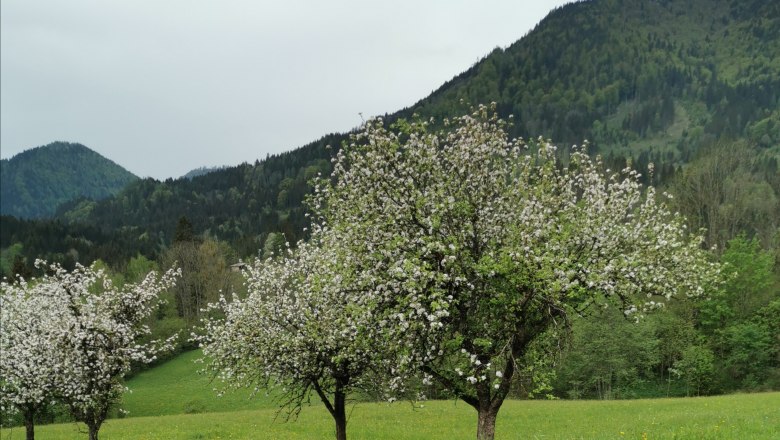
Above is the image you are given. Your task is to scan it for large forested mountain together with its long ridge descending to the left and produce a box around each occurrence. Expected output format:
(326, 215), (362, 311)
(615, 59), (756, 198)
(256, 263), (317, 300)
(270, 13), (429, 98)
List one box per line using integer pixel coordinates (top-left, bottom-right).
(2, 0), (780, 268)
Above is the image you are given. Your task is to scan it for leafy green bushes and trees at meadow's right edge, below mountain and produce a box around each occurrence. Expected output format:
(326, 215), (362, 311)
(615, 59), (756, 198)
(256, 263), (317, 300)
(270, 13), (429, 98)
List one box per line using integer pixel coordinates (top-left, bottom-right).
(555, 234), (780, 398)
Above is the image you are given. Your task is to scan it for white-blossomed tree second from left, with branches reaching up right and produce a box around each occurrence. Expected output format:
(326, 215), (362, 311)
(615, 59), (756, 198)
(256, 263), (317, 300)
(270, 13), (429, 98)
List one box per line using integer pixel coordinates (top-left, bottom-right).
(52, 265), (178, 440)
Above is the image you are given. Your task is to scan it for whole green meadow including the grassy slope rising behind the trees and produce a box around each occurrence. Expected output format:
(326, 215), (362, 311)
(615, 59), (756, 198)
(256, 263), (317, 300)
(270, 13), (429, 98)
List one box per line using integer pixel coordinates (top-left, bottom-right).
(0, 352), (780, 440)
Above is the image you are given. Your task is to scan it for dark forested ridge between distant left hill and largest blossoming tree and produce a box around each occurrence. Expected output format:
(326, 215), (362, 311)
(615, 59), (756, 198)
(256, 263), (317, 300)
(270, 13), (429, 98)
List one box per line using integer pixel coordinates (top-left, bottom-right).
(47, 135), (336, 257)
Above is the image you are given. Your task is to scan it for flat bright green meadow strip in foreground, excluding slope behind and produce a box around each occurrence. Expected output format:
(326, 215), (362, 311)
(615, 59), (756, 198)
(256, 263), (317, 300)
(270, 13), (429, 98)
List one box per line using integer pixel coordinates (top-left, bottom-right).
(7, 393), (780, 440)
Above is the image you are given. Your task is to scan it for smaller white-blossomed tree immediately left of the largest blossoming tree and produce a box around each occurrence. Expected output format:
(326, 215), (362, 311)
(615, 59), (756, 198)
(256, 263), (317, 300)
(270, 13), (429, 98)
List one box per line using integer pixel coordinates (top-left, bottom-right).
(195, 232), (388, 440)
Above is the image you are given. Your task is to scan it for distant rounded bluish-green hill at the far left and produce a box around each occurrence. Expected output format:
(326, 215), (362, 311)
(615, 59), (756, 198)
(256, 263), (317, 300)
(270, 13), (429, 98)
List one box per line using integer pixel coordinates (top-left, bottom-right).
(0, 142), (138, 218)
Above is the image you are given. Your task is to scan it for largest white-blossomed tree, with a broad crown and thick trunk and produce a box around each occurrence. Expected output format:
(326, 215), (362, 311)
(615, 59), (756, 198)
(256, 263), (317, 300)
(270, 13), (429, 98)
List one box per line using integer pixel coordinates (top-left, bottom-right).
(312, 107), (718, 439)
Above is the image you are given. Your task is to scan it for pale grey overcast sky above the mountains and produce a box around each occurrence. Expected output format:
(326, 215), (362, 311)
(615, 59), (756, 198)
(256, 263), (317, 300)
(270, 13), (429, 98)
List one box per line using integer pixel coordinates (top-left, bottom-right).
(0, 0), (567, 179)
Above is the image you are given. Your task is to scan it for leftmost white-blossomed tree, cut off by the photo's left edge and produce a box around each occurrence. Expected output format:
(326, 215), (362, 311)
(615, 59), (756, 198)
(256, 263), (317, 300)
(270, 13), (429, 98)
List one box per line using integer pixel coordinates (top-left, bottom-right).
(0, 279), (60, 440)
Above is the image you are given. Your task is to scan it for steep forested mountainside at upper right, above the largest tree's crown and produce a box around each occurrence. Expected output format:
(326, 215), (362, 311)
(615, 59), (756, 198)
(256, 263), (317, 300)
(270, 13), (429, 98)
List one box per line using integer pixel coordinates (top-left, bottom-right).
(404, 0), (780, 162)
